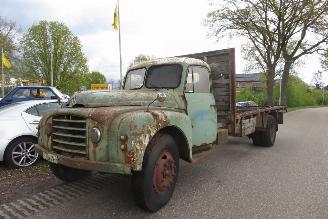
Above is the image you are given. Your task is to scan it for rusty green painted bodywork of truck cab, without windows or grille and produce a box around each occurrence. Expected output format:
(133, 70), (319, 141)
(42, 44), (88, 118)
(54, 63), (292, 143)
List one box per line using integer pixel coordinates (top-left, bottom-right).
(38, 58), (217, 174)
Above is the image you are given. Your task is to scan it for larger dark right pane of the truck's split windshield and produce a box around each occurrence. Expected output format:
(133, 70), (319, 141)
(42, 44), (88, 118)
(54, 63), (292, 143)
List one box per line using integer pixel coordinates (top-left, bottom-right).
(146, 64), (182, 88)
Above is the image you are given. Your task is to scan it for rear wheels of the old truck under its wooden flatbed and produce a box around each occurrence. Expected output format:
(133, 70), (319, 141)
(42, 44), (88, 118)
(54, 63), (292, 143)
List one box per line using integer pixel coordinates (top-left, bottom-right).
(252, 115), (277, 147)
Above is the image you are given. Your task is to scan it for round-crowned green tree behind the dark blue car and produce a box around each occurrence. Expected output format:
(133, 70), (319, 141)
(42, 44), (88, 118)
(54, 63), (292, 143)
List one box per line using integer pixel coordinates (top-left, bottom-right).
(22, 21), (88, 94)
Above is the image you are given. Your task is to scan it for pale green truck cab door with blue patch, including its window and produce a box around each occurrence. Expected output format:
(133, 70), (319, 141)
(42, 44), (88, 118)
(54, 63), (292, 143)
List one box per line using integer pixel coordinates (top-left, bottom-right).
(185, 66), (217, 146)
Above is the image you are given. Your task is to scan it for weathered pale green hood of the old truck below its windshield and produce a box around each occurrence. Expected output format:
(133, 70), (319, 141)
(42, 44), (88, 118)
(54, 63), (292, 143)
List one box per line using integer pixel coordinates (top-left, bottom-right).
(68, 90), (185, 109)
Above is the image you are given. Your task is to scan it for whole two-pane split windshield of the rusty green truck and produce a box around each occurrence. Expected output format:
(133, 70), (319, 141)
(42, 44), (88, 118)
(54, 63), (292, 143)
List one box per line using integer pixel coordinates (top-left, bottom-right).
(124, 64), (182, 90)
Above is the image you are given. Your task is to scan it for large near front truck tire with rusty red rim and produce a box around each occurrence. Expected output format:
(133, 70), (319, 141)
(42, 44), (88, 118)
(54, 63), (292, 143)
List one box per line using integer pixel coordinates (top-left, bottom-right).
(132, 134), (179, 212)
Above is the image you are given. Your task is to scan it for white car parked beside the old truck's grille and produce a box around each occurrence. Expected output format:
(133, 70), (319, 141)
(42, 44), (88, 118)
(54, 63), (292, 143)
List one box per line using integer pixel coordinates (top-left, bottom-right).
(0, 100), (61, 168)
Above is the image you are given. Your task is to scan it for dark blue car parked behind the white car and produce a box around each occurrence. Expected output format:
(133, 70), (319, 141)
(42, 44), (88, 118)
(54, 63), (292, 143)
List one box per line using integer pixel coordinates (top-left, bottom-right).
(0, 86), (69, 107)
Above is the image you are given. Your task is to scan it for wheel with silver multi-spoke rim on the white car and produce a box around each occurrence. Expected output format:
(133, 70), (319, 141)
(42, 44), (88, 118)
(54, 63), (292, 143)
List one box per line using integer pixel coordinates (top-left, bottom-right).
(4, 137), (39, 168)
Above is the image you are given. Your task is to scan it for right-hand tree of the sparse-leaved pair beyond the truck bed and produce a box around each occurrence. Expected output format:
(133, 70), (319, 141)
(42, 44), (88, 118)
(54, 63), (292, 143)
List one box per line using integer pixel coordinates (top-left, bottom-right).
(281, 0), (328, 104)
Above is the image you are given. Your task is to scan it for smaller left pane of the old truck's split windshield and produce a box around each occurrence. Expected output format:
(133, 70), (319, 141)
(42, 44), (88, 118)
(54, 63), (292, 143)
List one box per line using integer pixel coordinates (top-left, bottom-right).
(124, 68), (146, 90)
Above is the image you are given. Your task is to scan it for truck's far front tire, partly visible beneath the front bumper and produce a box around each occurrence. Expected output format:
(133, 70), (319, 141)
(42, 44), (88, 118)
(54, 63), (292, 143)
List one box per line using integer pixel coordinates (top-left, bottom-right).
(49, 163), (91, 182)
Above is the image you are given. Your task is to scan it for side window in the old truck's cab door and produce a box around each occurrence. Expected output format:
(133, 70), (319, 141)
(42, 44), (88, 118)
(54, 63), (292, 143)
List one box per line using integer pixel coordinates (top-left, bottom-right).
(185, 66), (210, 93)
